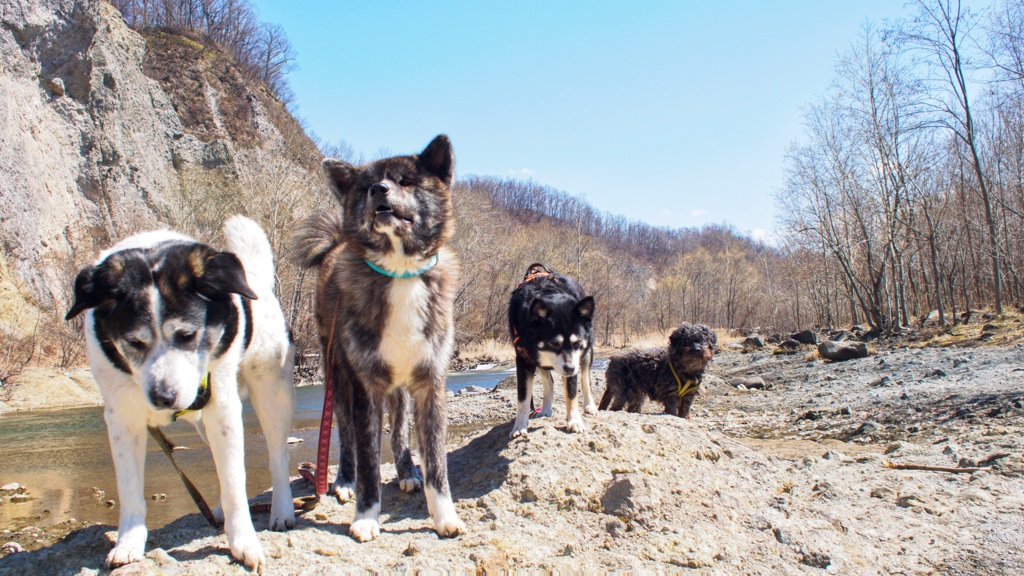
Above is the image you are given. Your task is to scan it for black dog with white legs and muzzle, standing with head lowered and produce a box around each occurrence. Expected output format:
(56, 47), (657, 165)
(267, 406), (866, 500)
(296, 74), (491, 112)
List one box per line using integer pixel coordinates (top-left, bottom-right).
(509, 263), (597, 438)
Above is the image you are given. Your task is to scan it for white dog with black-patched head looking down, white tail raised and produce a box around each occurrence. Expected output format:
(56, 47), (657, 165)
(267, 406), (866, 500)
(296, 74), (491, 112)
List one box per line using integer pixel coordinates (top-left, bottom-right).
(67, 216), (295, 570)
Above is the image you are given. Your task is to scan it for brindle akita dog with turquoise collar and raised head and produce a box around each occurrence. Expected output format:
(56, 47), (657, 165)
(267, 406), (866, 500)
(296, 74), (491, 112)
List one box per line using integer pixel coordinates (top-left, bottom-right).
(296, 134), (466, 542)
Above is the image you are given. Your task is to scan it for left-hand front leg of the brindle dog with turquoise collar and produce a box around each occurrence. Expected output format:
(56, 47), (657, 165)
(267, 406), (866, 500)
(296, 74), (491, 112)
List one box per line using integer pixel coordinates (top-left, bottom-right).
(348, 382), (384, 542)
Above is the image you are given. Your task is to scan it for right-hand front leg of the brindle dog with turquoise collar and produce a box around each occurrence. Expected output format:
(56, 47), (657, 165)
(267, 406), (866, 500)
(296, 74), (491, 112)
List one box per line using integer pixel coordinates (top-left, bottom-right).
(413, 376), (468, 537)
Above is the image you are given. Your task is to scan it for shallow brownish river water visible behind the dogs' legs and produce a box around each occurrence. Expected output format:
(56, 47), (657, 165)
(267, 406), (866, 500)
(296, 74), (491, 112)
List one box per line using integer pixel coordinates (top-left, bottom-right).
(0, 370), (514, 530)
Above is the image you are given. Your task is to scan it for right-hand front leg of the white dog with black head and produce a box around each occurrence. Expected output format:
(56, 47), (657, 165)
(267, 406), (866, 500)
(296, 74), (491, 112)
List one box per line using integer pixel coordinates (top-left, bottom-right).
(203, 373), (266, 571)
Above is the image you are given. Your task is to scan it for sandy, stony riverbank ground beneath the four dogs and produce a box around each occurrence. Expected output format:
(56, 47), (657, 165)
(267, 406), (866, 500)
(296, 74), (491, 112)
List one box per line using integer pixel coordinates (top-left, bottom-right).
(0, 330), (1024, 574)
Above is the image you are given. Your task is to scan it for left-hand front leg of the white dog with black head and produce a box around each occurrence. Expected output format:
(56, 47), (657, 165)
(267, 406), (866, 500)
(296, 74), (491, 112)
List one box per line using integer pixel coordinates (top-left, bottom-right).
(103, 394), (150, 568)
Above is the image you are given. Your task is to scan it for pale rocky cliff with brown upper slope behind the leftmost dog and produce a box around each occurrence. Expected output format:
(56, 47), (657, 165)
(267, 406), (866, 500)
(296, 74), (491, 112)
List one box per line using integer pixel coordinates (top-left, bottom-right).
(0, 0), (316, 329)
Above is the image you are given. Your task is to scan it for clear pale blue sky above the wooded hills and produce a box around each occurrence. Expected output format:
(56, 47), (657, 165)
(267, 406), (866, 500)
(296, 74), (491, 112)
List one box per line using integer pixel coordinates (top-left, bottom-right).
(254, 0), (937, 236)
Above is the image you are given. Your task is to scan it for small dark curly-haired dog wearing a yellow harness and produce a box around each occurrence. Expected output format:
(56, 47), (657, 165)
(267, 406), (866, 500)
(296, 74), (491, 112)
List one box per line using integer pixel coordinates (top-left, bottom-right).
(600, 322), (718, 418)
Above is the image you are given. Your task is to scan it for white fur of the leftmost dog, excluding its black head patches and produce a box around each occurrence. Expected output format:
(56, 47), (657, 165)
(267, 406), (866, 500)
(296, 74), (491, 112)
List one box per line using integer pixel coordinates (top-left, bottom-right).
(84, 216), (295, 570)
